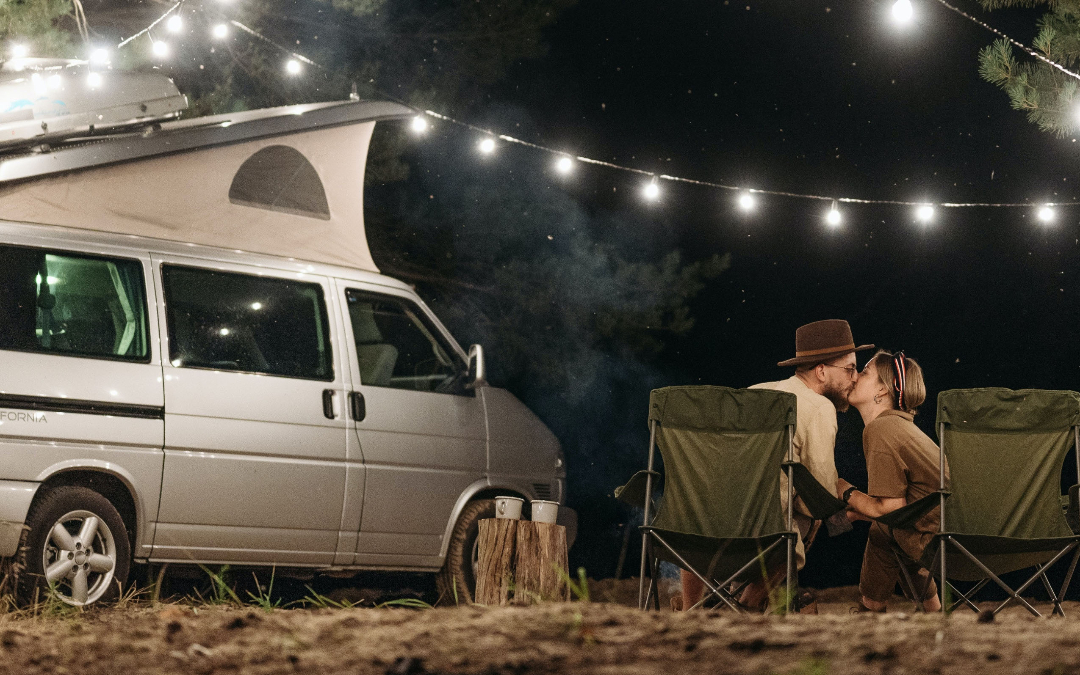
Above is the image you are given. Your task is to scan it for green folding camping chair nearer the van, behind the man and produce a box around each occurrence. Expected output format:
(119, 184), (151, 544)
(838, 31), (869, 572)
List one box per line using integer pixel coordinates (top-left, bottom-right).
(616, 387), (796, 611)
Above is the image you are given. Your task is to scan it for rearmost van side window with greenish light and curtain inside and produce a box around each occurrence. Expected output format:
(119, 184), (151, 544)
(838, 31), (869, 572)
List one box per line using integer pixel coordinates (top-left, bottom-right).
(0, 245), (150, 363)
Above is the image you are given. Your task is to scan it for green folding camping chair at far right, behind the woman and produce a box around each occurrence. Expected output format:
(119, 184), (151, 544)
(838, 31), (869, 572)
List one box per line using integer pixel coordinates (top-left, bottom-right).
(909, 388), (1080, 616)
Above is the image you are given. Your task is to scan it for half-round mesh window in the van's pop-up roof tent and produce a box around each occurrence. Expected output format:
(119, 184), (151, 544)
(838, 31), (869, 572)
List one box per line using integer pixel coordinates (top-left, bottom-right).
(229, 146), (330, 220)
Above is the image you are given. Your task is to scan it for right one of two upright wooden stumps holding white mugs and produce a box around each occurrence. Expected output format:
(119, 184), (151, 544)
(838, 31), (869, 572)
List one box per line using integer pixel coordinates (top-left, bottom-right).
(514, 521), (570, 605)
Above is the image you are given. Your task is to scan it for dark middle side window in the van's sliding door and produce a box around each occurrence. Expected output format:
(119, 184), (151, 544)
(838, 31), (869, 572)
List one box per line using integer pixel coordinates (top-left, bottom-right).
(161, 265), (334, 382)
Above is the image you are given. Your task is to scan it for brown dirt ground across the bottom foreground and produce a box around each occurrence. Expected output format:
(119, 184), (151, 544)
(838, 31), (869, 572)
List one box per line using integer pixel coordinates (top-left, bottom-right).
(0, 580), (1080, 675)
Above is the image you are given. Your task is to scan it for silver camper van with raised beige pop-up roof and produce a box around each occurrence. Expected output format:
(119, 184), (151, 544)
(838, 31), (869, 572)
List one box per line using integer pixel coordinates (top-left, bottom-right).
(0, 72), (573, 605)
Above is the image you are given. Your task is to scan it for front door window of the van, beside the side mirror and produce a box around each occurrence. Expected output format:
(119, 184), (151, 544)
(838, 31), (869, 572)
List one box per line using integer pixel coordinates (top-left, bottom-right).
(346, 289), (467, 393)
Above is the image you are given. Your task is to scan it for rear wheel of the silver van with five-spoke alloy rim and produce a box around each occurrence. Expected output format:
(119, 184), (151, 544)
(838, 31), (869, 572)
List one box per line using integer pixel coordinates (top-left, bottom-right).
(16, 486), (131, 606)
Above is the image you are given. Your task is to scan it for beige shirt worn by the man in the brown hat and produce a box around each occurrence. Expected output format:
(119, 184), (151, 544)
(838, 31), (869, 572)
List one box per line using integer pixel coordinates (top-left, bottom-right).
(751, 375), (837, 516)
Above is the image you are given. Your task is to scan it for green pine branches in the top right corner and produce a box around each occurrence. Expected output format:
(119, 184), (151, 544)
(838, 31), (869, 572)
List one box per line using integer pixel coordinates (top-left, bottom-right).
(978, 0), (1080, 136)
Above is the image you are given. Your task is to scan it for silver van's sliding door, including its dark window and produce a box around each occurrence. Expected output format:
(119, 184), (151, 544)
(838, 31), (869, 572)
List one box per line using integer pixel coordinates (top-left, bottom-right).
(153, 257), (346, 565)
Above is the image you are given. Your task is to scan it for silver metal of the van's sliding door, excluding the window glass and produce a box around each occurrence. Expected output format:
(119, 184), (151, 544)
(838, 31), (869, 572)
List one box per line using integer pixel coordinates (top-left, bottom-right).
(152, 255), (346, 565)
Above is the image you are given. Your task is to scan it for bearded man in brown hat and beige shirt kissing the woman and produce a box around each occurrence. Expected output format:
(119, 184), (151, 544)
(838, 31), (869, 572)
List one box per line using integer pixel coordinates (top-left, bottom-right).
(683, 319), (874, 608)
